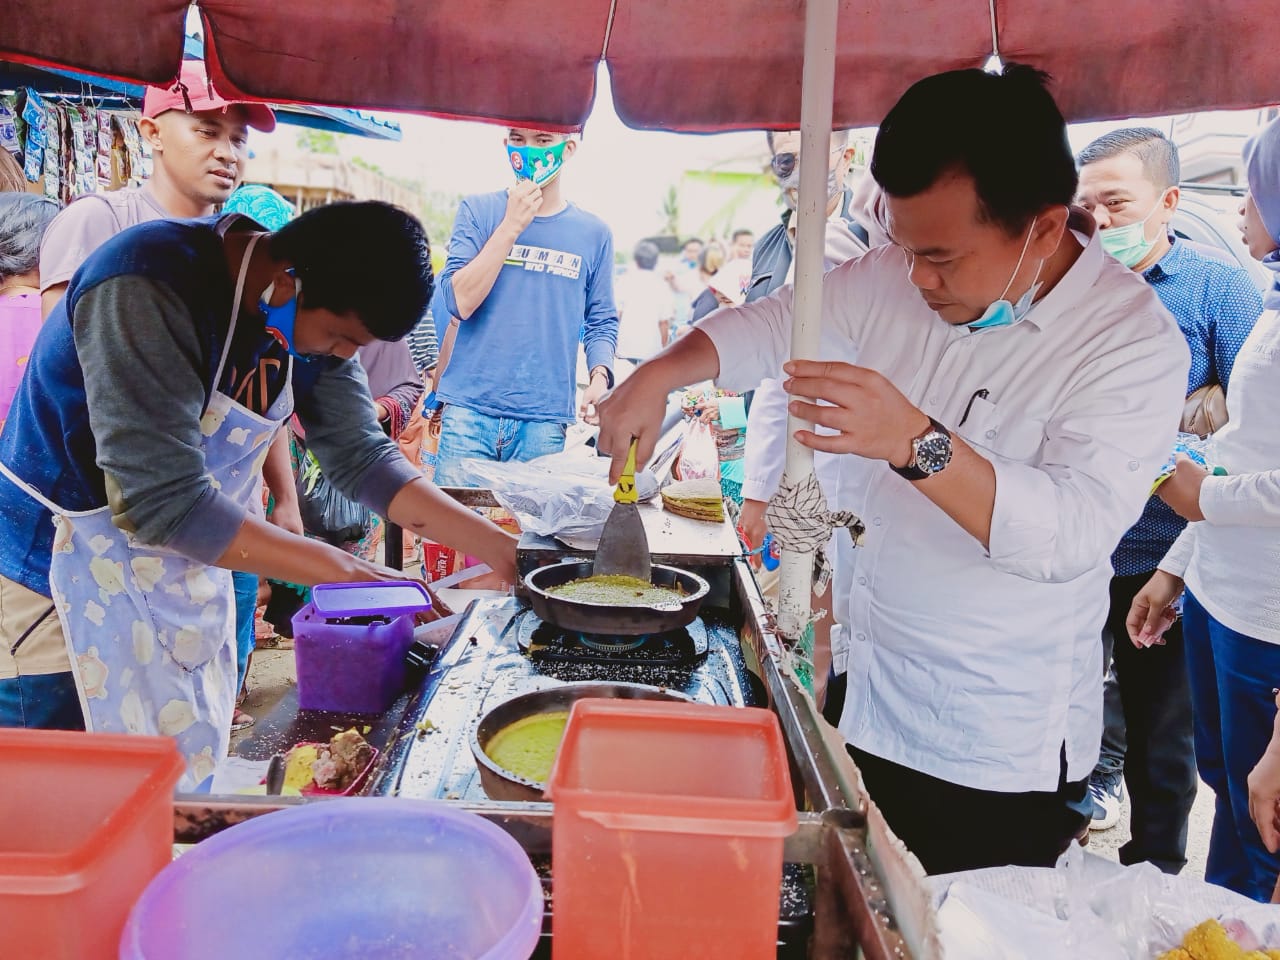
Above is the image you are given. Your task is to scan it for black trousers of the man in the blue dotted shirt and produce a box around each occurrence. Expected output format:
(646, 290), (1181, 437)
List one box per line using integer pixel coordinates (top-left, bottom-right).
(1097, 573), (1197, 873)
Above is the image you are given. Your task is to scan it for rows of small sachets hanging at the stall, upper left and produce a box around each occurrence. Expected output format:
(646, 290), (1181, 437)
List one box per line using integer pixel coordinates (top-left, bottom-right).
(0, 88), (151, 204)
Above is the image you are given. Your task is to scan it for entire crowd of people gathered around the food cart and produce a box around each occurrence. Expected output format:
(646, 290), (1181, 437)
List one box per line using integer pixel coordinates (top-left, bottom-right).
(0, 58), (1280, 900)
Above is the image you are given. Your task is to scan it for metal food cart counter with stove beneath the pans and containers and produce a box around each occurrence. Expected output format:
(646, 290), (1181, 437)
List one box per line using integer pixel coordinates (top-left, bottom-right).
(175, 489), (927, 960)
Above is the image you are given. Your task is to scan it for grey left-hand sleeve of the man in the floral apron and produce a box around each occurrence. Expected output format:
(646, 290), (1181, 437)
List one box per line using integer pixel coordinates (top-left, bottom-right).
(72, 275), (244, 563)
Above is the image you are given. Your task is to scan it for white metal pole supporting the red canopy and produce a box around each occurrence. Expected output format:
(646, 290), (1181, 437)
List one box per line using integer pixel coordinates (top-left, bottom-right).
(778, 0), (840, 640)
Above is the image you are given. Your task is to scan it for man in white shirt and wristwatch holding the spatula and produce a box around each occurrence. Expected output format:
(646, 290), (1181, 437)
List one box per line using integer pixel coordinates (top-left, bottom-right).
(599, 64), (1189, 873)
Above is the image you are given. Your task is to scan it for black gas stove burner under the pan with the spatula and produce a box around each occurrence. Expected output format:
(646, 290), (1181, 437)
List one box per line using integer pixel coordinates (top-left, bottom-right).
(516, 611), (707, 667)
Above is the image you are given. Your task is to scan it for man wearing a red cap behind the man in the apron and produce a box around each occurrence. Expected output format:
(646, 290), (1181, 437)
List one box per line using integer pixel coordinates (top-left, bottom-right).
(40, 60), (275, 316)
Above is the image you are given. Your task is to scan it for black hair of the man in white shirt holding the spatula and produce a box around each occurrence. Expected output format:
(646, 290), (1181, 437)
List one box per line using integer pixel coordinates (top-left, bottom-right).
(872, 63), (1076, 234)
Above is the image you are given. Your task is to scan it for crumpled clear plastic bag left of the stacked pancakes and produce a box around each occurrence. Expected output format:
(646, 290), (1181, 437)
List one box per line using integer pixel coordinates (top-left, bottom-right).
(462, 449), (658, 540)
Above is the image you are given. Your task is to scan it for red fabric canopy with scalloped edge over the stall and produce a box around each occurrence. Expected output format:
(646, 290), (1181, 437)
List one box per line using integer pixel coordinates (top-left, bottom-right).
(0, 0), (1280, 131)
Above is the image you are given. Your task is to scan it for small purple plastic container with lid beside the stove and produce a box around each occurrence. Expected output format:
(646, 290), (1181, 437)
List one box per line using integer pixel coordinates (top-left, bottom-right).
(293, 580), (431, 713)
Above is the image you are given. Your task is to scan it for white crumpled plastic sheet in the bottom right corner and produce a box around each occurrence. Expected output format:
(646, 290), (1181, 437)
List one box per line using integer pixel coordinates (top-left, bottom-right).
(929, 845), (1280, 960)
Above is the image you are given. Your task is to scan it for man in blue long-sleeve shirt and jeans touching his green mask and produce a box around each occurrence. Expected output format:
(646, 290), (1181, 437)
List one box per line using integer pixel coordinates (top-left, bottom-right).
(435, 127), (618, 486)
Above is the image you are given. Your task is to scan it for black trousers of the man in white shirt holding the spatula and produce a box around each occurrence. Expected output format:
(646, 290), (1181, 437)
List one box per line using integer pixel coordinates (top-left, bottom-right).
(849, 746), (1089, 874)
